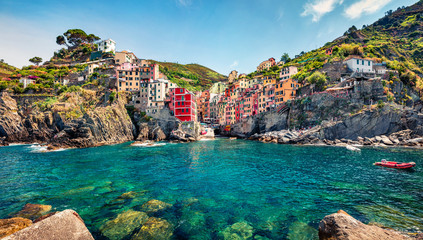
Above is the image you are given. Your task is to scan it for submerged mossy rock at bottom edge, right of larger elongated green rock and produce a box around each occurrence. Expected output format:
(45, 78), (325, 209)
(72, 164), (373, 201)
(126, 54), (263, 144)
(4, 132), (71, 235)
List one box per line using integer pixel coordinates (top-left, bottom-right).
(131, 217), (173, 240)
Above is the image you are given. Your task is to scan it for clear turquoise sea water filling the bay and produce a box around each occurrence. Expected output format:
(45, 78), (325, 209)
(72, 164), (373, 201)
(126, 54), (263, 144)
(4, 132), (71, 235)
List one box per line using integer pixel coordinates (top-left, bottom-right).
(0, 139), (423, 239)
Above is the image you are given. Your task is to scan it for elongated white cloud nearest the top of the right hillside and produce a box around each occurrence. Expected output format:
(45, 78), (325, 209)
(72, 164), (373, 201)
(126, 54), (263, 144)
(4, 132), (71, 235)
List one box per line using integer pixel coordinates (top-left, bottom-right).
(345, 0), (392, 19)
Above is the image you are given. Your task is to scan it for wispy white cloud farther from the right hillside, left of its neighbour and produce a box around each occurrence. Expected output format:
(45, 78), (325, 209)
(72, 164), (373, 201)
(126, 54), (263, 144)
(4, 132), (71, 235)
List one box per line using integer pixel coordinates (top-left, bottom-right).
(301, 0), (344, 22)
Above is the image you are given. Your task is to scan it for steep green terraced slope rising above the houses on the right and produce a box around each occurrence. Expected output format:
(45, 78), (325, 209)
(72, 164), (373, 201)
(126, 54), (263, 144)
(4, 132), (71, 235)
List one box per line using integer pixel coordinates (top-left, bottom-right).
(286, 1), (423, 90)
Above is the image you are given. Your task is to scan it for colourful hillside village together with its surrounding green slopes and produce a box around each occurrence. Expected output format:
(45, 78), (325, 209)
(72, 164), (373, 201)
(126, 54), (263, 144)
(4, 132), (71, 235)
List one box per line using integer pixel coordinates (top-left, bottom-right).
(0, 1), (423, 142)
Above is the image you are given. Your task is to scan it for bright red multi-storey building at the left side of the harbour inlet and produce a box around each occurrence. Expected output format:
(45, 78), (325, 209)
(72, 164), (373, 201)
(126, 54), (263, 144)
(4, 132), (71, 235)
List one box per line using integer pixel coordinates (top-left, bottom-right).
(169, 88), (197, 122)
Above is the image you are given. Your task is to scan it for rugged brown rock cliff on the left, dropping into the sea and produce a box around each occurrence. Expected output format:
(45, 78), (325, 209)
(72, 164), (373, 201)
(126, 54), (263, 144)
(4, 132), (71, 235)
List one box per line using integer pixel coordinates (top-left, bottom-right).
(0, 92), (135, 148)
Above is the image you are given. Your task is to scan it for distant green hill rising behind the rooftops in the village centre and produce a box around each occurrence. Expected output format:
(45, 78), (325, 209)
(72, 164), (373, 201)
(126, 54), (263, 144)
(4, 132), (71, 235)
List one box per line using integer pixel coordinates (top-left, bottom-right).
(151, 60), (227, 91)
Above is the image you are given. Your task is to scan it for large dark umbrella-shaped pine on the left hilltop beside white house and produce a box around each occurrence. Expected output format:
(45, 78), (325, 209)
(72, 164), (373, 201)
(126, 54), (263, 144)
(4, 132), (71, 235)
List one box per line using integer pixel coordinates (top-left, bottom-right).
(56, 29), (100, 48)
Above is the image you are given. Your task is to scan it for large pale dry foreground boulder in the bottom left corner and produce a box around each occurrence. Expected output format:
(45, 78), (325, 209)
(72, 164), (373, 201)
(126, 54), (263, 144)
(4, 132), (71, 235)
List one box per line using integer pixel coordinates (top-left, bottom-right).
(3, 210), (94, 240)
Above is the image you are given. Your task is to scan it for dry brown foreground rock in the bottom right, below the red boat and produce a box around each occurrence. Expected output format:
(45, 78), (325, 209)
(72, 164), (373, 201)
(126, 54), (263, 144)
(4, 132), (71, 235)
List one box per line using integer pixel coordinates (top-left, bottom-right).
(319, 210), (410, 240)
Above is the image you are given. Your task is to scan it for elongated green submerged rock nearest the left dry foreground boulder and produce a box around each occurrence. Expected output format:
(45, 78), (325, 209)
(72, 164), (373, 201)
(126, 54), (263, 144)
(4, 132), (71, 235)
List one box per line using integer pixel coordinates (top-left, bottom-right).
(100, 210), (148, 240)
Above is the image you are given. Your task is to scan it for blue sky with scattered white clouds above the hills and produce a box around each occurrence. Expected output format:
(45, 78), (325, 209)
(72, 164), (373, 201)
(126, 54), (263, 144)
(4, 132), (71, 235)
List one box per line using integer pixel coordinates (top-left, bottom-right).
(0, 0), (417, 75)
